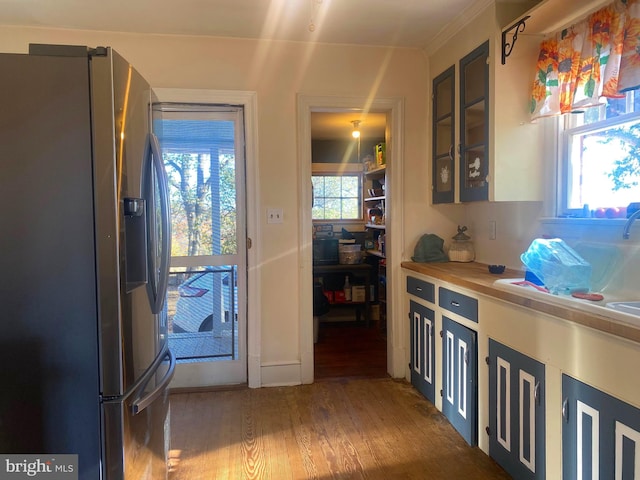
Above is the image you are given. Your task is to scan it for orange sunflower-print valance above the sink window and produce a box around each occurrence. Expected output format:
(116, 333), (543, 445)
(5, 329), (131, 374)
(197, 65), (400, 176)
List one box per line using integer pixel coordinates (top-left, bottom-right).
(531, 0), (640, 119)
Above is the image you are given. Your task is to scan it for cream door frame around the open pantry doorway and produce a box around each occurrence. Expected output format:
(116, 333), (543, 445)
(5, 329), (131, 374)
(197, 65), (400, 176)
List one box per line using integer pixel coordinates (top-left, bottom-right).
(297, 94), (407, 383)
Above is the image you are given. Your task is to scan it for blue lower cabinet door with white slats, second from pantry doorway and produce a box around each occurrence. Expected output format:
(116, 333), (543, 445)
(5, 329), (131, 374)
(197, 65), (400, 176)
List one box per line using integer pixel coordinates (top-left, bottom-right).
(441, 316), (478, 445)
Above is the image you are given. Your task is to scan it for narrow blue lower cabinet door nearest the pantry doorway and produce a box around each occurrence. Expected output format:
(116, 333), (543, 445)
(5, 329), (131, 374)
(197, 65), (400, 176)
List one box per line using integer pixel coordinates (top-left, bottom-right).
(409, 300), (435, 403)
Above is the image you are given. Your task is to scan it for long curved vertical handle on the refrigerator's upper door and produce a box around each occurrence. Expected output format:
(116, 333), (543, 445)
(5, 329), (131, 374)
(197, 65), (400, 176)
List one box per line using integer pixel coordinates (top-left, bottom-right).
(148, 133), (171, 313)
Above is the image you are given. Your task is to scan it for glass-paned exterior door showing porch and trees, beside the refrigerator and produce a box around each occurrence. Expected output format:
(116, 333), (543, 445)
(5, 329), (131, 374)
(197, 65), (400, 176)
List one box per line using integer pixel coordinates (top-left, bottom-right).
(153, 103), (247, 387)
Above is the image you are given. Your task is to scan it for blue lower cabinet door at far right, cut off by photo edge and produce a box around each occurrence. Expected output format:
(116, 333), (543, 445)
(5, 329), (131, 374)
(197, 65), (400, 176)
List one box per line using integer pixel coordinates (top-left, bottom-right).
(562, 374), (640, 480)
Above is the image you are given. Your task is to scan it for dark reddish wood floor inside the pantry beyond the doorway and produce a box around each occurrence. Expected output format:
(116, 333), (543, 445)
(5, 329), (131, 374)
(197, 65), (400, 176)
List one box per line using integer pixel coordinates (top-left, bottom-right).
(314, 322), (388, 381)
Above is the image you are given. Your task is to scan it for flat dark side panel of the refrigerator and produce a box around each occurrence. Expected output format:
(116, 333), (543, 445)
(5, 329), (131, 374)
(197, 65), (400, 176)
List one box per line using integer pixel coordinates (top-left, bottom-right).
(0, 50), (101, 480)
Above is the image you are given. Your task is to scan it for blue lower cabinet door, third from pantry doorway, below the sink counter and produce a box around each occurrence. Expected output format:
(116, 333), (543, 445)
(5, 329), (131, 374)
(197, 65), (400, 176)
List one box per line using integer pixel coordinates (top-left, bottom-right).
(489, 338), (545, 479)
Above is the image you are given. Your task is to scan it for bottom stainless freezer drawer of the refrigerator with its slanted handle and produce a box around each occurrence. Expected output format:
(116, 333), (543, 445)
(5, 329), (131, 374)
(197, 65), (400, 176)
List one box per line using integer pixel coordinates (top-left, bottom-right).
(103, 349), (175, 480)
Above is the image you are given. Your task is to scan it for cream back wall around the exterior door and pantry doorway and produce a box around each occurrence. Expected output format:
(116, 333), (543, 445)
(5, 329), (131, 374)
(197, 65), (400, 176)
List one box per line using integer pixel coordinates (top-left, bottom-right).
(0, 27), (444, 383)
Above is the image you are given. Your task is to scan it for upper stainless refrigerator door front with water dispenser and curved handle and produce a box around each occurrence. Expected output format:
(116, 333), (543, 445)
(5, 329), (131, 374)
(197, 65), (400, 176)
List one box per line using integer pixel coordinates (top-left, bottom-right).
(91, 48), (170, 399)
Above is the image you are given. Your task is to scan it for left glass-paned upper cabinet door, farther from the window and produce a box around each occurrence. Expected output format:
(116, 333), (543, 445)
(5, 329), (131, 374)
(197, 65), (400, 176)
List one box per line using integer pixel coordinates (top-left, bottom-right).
(432, 65), (455, 203)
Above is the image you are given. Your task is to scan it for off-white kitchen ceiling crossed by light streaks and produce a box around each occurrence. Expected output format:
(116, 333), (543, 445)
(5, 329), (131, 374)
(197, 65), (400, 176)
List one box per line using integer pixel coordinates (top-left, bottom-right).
(0, 0), (478, 48)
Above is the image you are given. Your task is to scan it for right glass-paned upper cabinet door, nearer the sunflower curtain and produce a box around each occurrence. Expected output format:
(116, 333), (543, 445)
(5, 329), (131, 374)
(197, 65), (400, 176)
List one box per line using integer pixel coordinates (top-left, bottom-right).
(460, 42), (489, 202)
